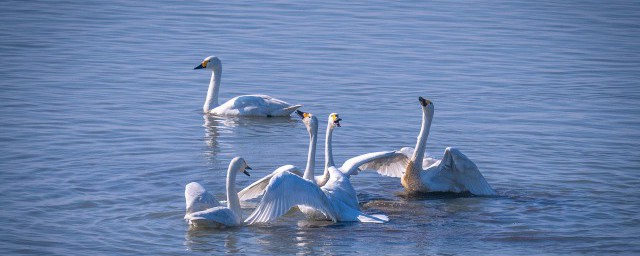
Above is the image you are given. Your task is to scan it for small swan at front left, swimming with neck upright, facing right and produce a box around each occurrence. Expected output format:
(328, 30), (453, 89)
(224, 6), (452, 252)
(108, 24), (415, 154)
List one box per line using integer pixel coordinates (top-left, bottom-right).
(184, 157), (251, 228)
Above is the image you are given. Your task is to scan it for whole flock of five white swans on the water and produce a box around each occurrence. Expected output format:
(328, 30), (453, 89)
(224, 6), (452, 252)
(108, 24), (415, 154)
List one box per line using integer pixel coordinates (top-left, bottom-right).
(184, 56), (495, 228)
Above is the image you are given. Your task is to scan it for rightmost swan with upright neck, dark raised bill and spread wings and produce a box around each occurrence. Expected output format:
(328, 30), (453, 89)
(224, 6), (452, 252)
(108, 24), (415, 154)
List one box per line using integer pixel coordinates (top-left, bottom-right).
(347, 97), (496, 195)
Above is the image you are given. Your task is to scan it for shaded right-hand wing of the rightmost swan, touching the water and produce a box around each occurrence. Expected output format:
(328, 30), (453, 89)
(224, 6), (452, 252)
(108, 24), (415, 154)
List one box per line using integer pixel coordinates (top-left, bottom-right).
(429, 147), (496, 195)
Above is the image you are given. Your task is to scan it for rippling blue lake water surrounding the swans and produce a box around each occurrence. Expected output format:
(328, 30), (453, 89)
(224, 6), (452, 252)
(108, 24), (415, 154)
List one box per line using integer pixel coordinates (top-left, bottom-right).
(0, 1), (640, 255)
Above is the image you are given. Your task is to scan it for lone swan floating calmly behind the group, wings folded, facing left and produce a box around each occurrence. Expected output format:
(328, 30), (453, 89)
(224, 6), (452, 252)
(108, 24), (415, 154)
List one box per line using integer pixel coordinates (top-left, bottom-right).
(194, 56), (302, 117)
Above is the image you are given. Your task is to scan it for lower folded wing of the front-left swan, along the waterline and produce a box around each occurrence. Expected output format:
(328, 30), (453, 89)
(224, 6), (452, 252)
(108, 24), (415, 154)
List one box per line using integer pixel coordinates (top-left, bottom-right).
(184, 206), (240, 227)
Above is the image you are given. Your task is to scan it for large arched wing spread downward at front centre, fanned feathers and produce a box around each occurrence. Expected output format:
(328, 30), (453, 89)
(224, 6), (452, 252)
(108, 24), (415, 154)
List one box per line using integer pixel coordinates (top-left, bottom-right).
(245, 172), (337, 224)
